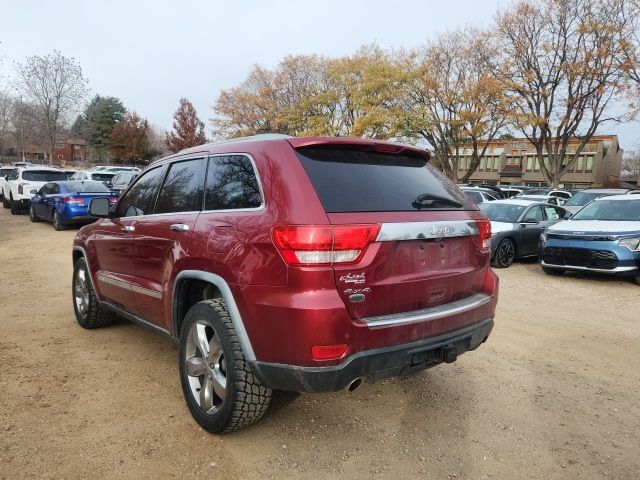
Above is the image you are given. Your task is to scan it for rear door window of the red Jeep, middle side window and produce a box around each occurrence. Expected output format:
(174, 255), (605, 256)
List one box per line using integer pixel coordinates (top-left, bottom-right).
(154, 158), (204, 213)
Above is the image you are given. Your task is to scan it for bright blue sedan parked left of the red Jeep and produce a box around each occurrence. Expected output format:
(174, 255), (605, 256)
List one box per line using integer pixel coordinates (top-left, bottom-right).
(29, 180), (118, 230)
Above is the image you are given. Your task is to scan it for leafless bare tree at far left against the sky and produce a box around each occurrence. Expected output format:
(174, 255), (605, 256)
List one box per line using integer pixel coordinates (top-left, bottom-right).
(16, 50), (87, 162)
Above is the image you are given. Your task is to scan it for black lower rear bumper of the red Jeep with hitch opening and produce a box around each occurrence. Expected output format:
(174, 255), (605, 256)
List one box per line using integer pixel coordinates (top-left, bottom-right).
(251, 318), (493, 393)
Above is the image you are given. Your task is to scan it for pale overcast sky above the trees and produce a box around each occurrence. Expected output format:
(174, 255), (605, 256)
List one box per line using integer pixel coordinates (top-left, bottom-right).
(0, 0), (640, 150)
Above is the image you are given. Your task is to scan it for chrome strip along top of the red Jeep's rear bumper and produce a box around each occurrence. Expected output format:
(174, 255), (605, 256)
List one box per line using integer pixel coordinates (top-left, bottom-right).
(359, 293), (491, 328)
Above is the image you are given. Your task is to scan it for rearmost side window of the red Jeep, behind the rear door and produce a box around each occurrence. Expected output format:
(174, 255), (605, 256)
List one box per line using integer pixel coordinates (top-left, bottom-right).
(204, 155), (262, 210)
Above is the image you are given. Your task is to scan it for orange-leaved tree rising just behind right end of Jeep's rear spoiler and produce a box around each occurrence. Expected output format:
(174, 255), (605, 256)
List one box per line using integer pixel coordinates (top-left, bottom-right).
(399, 29), (508, 180)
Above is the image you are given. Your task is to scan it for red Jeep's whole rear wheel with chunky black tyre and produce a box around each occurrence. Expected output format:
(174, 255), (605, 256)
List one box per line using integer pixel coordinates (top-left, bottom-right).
(179, 299), (271, 433)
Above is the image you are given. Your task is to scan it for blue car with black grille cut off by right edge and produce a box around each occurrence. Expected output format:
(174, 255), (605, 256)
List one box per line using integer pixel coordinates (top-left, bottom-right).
(540, 195), (640, 285)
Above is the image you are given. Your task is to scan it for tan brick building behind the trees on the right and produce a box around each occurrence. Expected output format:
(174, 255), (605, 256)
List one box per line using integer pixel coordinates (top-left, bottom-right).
(458, 135), (624, 188)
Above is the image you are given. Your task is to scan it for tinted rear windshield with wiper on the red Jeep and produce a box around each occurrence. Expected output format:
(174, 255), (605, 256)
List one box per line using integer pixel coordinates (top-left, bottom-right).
(296, 148), (475, 212)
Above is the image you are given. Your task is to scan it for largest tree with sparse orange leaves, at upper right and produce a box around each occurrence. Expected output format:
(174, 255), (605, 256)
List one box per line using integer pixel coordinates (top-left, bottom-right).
(496, 0), (628, 186)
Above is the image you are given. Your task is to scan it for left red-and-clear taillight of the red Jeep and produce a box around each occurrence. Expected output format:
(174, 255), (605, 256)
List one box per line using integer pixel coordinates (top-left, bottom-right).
(273, 224), (380, 265)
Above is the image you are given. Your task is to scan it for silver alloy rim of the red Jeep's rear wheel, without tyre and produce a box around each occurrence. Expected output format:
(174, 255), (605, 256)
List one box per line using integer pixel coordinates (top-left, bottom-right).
(185, 320), (227, 414)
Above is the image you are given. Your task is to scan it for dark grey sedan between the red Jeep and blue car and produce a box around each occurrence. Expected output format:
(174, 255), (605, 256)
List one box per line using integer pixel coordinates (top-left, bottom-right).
(480, 198), (566, 268)
